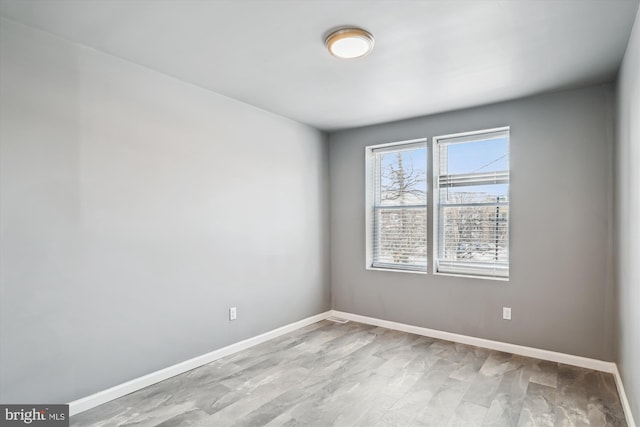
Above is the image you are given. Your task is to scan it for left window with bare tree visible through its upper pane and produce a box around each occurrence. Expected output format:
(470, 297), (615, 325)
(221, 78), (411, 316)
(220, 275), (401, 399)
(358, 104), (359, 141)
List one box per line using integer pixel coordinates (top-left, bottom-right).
(367, 139), (427, 271)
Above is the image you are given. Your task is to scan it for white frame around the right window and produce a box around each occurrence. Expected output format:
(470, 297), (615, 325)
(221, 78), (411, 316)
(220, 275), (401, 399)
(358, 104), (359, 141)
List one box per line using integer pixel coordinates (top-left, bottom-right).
(429, 126), (511, 281)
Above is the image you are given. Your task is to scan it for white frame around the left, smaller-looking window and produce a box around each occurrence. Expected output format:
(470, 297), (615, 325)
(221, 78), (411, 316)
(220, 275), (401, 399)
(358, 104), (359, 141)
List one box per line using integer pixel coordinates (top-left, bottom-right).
(365, 138), (430, 274)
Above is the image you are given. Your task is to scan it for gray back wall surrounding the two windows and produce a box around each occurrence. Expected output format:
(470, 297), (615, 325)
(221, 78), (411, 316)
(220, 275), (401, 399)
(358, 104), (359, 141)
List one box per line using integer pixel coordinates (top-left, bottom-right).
(329, 85), (614, 360)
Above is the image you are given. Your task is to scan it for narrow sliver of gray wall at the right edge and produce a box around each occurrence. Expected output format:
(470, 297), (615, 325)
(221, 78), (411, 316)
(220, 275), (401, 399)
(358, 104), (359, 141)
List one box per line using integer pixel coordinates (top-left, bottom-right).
(616, 5), (640, 422)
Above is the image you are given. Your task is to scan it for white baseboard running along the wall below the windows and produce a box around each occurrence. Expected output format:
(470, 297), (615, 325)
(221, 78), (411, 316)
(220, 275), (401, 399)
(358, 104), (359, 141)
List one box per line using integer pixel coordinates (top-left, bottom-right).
(331, 310), (616, 374)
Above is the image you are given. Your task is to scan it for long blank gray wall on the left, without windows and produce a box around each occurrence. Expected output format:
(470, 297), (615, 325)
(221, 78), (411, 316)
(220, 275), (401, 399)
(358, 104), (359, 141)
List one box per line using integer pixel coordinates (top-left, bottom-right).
(0, 20), (330, 403)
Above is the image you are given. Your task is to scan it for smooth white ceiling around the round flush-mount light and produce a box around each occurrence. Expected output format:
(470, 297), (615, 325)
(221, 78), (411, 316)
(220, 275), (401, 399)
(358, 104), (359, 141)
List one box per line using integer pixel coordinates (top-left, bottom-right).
(0, 0), (638, 130)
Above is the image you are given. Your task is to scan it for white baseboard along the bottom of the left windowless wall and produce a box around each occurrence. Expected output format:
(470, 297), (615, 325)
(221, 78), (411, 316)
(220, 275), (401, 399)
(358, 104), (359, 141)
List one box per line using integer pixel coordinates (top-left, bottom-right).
(69, 311), (331, 416)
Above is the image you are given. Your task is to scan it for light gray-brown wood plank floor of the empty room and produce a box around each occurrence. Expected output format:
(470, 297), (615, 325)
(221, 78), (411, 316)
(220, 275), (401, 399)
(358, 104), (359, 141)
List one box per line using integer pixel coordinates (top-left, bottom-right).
(71, 321), (626, 427)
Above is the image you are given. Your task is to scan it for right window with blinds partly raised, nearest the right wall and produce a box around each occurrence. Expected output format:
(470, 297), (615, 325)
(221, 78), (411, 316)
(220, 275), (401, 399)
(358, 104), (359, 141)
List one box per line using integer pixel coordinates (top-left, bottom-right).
(433, 128), (509, 278)
